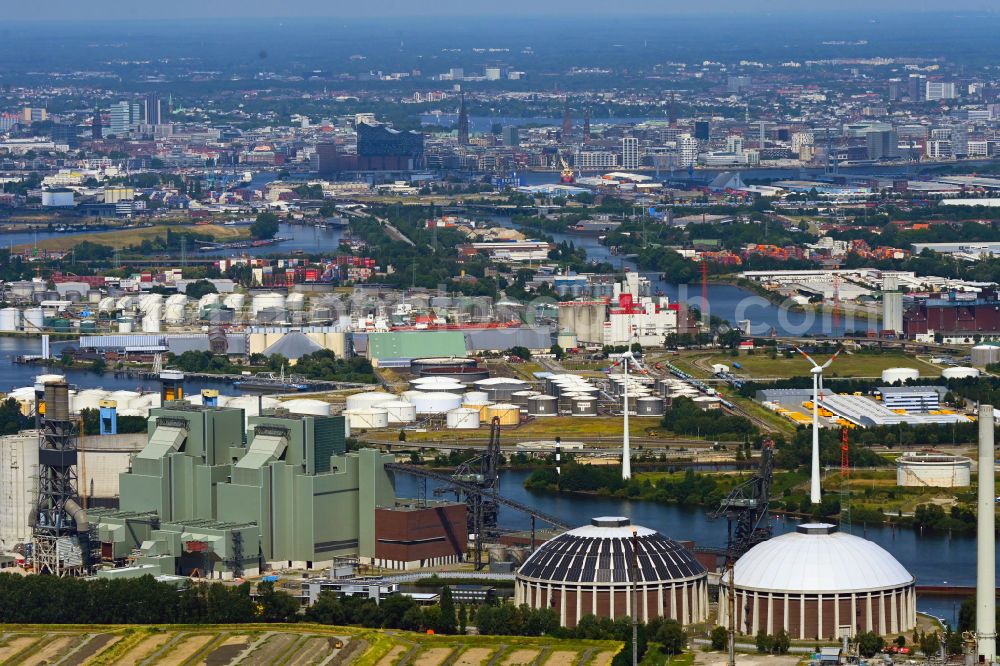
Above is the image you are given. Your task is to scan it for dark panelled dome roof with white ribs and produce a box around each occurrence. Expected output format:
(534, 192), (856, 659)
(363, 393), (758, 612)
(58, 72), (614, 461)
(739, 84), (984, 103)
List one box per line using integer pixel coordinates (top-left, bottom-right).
(517, 517), (705, 583)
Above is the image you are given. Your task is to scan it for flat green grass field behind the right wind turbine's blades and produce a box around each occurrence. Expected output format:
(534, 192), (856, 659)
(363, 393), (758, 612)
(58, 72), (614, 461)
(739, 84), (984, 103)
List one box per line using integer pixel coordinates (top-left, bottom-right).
(689, 351), (941, 378)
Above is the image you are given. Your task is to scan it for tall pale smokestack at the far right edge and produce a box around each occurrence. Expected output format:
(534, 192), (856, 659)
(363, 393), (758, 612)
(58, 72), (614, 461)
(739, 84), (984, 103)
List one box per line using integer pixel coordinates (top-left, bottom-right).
(976, 405), (997, 664)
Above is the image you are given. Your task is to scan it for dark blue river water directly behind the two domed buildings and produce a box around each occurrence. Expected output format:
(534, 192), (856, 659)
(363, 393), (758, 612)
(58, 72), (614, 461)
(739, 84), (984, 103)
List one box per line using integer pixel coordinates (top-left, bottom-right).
(396, 464), (976, 626)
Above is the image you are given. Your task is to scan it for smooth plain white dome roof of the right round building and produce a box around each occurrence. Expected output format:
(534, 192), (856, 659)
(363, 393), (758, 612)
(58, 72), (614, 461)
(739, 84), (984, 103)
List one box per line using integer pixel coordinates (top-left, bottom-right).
(735, 523), (914, 593)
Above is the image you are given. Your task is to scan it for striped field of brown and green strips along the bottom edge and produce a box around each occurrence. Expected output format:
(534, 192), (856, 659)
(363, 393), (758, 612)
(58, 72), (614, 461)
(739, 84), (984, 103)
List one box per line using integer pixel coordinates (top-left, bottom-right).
(0, 624), (622, 666)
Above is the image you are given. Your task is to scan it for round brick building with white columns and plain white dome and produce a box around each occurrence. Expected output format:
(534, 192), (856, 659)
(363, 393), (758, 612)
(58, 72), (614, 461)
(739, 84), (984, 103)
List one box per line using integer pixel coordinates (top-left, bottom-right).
(719, 523), (917, 640)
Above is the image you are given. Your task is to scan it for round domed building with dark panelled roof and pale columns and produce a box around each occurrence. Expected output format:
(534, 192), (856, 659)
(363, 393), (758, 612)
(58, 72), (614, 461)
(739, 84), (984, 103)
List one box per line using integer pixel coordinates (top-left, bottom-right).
(514, 517), (708, 627)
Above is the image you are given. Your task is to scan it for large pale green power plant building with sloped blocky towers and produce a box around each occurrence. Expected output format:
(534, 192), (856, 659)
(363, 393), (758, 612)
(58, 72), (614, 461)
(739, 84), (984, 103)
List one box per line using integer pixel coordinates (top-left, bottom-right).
(92, 402), (395, 577)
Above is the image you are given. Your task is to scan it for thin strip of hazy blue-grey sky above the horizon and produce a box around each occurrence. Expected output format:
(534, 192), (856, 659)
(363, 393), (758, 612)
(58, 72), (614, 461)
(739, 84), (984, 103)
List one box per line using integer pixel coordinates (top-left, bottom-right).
(9, 0), (997, 21)
